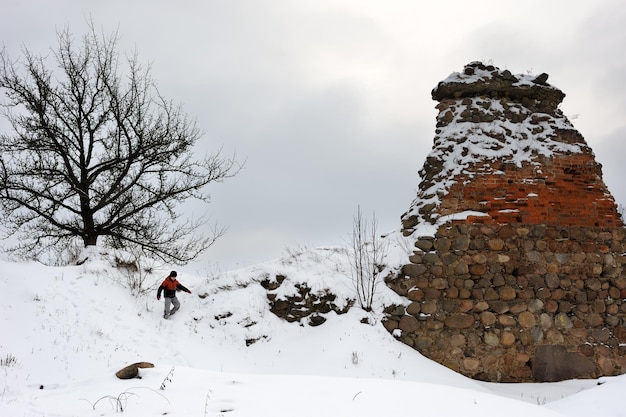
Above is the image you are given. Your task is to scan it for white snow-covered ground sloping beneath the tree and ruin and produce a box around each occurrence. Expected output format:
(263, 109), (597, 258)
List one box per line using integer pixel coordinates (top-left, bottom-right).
(0, 242), (626, 417)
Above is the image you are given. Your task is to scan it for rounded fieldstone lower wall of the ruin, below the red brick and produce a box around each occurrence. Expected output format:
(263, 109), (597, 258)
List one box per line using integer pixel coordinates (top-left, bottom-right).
(385, 222), (626, 382)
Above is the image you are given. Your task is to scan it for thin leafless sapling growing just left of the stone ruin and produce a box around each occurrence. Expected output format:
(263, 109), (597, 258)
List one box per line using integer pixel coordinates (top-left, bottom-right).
(350, 206), (386, 311)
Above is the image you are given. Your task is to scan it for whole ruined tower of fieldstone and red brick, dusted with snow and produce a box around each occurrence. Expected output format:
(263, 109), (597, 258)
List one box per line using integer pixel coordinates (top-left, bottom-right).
(385, 62), (626, 382)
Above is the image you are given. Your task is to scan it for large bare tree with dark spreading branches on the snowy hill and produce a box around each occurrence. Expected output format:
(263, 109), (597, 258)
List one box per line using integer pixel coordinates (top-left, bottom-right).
(0, 23), (241, 264)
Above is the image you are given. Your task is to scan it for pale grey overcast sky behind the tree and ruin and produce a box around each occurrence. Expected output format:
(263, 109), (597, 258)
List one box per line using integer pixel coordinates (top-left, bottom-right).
(0, 0), (626, 273)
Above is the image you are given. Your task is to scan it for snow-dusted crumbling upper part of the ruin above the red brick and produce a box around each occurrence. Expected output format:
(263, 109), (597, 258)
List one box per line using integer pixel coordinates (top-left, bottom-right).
(402, 62), (587, 229)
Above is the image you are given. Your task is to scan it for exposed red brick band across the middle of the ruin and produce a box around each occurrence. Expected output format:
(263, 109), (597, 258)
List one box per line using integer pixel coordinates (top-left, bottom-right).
(439, 153), (623, 227)
